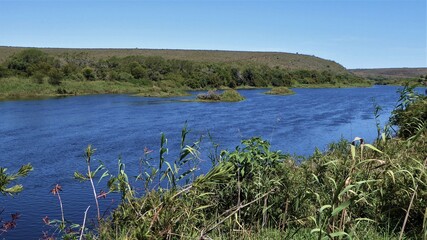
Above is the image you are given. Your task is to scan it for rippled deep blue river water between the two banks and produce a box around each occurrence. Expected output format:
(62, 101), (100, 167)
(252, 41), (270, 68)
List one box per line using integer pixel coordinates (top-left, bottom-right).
(0, 86), (424, 239)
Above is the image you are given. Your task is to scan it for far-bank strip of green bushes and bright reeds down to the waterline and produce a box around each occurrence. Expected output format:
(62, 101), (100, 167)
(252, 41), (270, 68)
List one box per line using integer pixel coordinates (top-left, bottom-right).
(0, 49), (369, 99)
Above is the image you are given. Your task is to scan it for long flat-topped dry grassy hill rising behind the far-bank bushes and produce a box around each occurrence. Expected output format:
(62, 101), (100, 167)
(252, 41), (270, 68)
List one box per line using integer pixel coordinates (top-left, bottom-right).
(0, 46), (347, 73)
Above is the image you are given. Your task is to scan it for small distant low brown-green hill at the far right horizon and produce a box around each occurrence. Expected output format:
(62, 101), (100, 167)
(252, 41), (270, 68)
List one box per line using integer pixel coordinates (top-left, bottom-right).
(349, 68), (427, 79)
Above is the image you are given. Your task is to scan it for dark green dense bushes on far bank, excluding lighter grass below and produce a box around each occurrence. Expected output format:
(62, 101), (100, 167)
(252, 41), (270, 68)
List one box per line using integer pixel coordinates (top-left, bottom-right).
(0, 49), (364, 89)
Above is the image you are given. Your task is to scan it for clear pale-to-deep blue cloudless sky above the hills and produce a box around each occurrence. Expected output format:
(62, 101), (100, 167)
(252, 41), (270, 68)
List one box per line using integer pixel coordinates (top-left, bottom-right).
(0, 0), (427, 68)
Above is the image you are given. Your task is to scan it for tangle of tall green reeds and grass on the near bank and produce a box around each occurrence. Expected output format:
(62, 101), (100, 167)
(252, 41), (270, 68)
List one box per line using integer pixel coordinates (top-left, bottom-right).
(93, 130), (427, 239)
